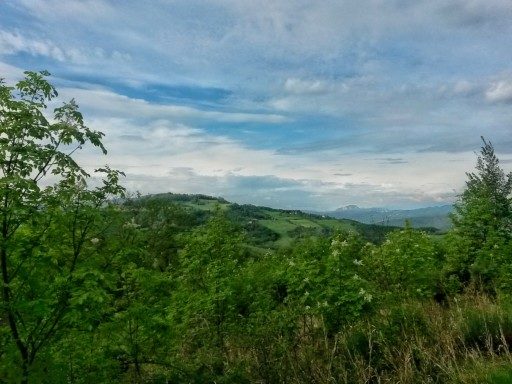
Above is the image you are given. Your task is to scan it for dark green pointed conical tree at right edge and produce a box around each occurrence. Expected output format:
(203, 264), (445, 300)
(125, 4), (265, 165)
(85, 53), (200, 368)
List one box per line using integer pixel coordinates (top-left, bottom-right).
(448, 137), (512, 290)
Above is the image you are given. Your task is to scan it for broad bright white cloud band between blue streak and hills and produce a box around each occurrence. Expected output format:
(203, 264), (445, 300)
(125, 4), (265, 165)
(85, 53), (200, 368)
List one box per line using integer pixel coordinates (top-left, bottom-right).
(74, 113), (474, 209)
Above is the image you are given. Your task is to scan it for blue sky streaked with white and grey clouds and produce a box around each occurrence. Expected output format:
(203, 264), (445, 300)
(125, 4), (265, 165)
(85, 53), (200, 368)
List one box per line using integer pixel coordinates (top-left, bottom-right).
(0, 0), (512, 211)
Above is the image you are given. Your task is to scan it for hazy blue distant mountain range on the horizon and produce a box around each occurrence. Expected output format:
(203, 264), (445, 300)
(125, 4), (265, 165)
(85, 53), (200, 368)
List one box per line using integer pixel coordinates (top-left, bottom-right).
(317, 205), (453, 231)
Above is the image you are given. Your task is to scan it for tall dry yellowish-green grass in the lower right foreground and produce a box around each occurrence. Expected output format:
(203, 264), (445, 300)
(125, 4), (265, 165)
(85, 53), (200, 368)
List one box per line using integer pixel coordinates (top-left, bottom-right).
(213, 293), (512, 384)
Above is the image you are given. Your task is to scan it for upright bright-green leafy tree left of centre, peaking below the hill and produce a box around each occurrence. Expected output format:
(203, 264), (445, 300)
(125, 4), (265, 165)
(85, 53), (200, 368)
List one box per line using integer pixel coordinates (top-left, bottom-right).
(169, 211), (246, 371)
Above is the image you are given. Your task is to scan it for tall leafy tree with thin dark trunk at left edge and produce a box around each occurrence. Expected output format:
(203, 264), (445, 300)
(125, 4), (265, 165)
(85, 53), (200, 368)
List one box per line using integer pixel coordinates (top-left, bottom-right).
(0, 71), (124, 383)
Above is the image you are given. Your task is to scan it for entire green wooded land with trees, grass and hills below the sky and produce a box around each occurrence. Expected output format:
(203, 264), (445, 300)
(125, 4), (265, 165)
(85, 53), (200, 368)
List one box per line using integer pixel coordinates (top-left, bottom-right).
(0, 72), (512, 384)
